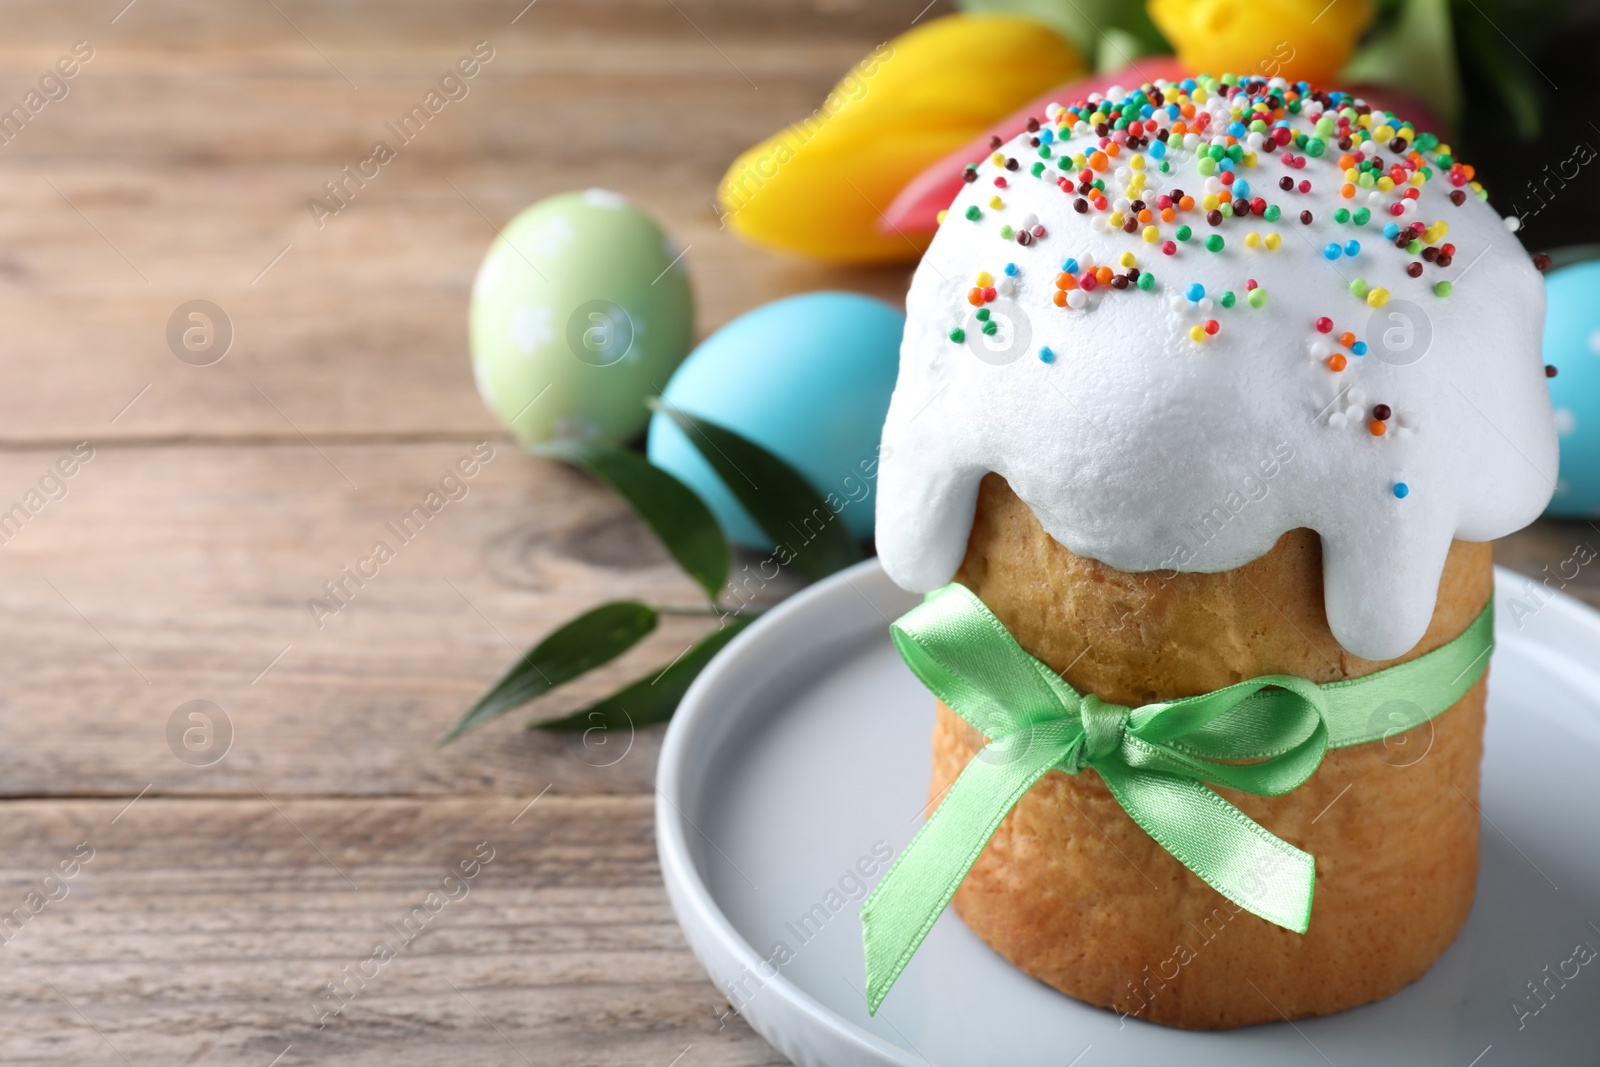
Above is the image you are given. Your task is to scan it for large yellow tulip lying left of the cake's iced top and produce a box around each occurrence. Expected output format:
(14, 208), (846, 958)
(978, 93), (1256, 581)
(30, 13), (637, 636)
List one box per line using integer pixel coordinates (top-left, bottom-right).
(717, 14), (1085, 264)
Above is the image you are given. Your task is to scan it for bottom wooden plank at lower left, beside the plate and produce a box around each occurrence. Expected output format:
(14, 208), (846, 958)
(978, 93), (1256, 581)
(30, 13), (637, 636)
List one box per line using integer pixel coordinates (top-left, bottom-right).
(0, 797), (784, 1067)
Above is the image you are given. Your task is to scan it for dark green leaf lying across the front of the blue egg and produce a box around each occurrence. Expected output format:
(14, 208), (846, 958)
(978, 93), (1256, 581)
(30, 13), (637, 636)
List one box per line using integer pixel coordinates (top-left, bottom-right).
(651, 402), (861, 582)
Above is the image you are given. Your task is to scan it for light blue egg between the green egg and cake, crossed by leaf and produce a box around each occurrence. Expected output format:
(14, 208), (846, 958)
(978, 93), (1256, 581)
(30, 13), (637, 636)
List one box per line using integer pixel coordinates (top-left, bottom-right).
(650, 293), (906, 550)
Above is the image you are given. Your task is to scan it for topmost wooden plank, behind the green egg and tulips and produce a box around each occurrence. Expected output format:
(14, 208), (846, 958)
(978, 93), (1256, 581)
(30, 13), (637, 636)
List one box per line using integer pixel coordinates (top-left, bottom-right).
(0, 0), (914, 443)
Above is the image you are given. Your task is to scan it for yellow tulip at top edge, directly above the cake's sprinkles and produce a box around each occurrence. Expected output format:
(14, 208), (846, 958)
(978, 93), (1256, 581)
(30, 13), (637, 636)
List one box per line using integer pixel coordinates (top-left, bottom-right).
(1149, 0), (1373, 86)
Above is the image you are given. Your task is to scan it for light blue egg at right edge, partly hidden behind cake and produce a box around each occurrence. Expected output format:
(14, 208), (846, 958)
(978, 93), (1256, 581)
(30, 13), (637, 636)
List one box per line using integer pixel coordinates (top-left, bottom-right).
(1544, 259), (1600, 518)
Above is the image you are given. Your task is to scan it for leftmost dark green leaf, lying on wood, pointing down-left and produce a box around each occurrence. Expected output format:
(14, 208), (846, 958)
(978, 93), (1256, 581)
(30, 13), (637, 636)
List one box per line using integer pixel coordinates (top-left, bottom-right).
(437, 600), (658, 744)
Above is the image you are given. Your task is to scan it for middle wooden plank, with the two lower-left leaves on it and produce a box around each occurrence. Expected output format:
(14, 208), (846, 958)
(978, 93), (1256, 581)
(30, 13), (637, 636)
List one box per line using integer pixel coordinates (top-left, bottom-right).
(0, 443), (784, 797)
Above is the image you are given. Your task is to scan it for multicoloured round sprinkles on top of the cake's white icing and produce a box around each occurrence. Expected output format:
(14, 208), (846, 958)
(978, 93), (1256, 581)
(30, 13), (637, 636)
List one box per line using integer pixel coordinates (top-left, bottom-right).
(941, 75), (1529, 499)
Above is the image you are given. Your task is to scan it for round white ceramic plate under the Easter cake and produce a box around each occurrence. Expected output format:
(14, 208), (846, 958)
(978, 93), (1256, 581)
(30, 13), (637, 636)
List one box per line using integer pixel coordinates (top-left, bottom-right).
(656, 561), (1600, 1067)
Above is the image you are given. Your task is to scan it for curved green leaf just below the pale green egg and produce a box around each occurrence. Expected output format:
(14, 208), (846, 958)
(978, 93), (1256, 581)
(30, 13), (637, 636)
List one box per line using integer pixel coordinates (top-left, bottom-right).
(531, 442), (728, 603)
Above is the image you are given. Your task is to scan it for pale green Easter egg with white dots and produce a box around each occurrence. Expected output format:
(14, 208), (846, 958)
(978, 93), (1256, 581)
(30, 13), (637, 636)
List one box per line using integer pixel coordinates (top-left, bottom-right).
(470, 189), (694, 445)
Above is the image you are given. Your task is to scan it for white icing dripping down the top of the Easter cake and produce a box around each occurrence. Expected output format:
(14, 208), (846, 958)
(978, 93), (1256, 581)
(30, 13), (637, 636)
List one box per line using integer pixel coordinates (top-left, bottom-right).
(877, 79), (1557, 659)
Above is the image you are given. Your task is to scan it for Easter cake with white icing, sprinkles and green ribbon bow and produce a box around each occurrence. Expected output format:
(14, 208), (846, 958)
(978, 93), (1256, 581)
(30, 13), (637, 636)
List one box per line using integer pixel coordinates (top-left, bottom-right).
(862, 77), (1557, 1027)
